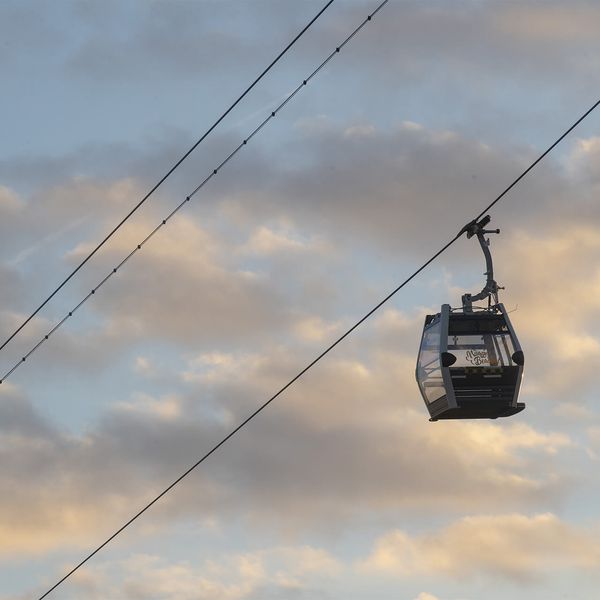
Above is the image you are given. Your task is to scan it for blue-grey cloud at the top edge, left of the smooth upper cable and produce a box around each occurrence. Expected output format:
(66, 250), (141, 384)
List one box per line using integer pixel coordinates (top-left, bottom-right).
(63, 2), (340, 82)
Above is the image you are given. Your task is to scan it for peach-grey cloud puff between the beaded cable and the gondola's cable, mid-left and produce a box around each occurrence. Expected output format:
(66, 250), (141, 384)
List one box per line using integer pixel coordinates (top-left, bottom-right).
(62, 217), (296, 344)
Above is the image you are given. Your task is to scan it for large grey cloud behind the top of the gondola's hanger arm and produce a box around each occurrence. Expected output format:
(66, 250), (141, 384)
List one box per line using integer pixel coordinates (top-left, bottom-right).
(216, 124), (569, 254)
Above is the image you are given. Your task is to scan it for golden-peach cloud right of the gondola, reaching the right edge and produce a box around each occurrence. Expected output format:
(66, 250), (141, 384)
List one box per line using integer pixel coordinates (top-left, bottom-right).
(496, 223), (600, 402)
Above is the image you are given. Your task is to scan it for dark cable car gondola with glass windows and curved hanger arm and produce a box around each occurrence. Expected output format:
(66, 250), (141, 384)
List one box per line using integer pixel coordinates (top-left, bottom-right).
(416, 216), (525, 421)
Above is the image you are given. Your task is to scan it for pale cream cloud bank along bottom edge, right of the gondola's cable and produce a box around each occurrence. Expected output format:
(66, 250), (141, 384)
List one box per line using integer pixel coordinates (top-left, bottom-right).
(38, 546), (343, 600)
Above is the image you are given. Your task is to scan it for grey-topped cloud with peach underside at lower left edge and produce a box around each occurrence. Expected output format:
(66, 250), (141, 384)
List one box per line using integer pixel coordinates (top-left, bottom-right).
(0, 393), (225, 557)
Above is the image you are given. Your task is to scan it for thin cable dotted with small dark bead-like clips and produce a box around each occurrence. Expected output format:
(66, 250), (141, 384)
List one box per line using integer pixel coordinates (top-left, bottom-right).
(0, 0), (389, 384)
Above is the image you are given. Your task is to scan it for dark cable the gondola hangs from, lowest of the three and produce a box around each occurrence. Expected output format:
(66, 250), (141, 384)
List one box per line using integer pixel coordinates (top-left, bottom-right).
(38, 90), (600, 600)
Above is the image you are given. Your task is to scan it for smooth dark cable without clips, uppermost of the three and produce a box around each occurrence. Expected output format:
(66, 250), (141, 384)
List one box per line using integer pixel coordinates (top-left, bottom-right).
(0, 0), (334, 350)
